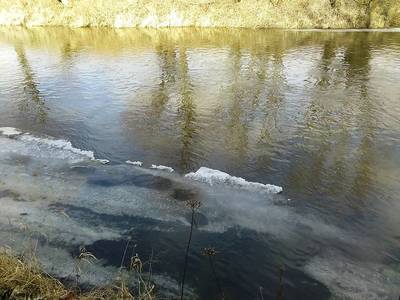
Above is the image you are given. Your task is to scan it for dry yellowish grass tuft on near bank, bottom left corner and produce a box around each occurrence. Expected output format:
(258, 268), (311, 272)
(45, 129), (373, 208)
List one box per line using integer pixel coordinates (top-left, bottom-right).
(0, 249), (155, 300)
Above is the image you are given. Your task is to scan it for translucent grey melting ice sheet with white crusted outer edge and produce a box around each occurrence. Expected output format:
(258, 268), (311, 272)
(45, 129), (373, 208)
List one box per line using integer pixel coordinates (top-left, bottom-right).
(0, 128), (398, 299)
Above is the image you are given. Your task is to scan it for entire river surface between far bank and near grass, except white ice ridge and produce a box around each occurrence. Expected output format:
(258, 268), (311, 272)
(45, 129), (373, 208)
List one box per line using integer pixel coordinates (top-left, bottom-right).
(0, 27), (400, 299)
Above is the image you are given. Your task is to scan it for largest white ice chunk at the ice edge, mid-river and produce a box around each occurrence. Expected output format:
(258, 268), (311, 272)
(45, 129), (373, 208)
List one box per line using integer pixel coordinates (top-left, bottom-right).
(185, 167), (283, 194)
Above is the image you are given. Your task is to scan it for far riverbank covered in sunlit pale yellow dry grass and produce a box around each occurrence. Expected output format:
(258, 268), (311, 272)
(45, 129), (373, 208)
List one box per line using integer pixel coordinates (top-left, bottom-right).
(0, 0), (400, 28)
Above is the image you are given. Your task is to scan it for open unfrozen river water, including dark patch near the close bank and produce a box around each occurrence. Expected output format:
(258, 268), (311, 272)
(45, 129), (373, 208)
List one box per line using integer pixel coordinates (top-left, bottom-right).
(0, 28), (400, 299)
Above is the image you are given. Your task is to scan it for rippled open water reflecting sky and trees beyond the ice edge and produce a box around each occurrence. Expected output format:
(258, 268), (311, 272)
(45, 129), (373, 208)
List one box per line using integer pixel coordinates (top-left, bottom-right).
(0, 29), (400, 298)
